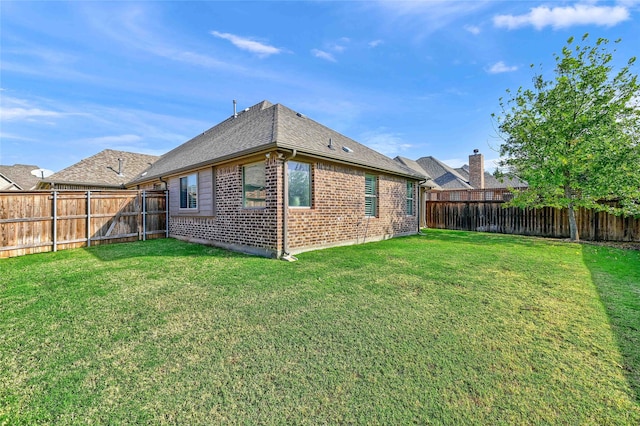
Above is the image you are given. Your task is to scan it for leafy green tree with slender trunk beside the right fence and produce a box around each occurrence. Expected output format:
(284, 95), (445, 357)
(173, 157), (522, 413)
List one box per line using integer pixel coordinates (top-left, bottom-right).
(492, 34), (640, 241)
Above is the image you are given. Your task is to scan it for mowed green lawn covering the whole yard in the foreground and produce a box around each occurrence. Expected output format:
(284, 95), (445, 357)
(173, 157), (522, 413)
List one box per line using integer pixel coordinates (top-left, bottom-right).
(0, 230), (640, 425)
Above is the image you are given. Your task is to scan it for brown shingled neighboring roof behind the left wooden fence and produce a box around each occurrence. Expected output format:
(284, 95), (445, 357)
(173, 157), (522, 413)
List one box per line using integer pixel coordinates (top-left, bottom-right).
(38, 149), (160, 190)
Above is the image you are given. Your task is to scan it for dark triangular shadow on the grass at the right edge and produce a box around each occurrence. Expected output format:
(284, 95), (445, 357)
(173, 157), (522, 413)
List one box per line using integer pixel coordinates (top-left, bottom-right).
(582, 245), (640, 403)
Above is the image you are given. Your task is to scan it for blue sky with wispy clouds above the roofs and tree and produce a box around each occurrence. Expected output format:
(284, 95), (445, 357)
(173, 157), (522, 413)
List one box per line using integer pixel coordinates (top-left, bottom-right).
(0, 0), (640, 171)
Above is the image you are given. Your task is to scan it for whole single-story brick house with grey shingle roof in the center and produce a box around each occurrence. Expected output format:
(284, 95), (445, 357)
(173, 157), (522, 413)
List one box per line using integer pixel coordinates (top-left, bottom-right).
(127, 101), (423, 259)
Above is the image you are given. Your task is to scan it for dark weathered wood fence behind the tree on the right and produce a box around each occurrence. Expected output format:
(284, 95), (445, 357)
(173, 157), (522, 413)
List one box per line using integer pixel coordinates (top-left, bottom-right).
(425, 189), (640, 241)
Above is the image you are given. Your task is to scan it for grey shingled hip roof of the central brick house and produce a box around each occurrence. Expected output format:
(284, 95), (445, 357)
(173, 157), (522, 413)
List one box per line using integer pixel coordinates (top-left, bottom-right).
(129, 101), (422, 185)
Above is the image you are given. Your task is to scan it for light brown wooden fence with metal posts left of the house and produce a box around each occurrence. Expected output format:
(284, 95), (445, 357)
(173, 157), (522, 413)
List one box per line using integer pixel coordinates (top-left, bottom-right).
(0, 190), (168, 258)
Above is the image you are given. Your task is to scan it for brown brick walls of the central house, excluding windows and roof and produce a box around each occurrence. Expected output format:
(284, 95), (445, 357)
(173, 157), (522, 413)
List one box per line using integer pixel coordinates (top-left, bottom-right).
(168, 152), (418, 257)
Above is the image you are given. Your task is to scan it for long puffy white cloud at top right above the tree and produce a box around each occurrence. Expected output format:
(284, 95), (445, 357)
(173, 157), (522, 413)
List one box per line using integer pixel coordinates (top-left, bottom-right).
(493, 4), (629, 30)
